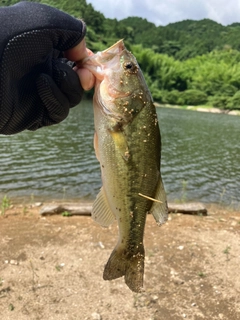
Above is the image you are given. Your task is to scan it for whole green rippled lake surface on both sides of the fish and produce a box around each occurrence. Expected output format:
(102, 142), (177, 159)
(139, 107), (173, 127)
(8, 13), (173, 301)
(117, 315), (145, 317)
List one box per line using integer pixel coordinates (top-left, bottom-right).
(0, 101), (240, 206)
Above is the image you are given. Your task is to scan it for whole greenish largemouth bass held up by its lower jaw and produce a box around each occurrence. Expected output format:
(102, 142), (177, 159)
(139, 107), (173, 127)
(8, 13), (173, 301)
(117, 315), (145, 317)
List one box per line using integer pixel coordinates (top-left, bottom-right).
(83, 40), (168, 292)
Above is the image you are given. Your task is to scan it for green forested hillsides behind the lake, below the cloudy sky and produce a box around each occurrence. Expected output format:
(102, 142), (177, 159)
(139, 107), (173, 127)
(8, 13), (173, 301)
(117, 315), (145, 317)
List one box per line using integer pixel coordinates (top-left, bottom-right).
(0, 0), (240, 110)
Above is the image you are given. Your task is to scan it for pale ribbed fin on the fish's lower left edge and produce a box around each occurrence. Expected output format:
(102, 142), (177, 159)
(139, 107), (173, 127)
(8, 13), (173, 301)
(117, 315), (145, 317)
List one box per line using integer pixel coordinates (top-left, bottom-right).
(92, 188), (115, 227)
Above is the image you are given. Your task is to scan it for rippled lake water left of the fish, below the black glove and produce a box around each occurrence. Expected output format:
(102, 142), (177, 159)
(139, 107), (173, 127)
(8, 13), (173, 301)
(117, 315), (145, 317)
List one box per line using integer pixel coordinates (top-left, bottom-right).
(0, 102), (101, 200)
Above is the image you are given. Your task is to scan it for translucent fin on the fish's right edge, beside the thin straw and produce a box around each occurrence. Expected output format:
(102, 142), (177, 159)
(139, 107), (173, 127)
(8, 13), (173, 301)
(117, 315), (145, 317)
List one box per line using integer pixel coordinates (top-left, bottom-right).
(150, 177), (168, 224)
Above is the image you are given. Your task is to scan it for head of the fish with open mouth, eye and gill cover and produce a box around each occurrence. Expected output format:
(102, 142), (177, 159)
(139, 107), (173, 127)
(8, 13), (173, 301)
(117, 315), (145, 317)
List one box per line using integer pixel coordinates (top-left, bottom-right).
(84, 40), (152, 122)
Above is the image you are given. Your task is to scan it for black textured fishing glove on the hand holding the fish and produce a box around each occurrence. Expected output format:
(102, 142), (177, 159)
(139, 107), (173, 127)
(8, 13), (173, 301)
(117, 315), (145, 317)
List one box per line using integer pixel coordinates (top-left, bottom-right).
(0, 2), (86, 134)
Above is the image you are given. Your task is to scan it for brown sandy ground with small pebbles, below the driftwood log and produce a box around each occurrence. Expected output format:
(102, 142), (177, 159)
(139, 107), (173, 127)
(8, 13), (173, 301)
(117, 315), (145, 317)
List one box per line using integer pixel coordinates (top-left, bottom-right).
(0, 206), (240, 320)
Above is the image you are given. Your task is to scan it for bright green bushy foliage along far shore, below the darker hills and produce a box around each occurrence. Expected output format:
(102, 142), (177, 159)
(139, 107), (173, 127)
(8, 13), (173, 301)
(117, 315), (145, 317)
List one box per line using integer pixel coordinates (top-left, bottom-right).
(131, 45), (240, 109)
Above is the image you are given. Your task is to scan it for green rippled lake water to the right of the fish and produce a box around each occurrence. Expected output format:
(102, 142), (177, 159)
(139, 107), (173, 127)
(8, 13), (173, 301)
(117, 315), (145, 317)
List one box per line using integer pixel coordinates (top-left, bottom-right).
(159, 109), (240, 206)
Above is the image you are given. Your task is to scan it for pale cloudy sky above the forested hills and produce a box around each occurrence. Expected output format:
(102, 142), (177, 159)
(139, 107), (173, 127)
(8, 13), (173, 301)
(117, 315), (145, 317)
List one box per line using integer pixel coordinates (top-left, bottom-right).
(87, 0), (240, 26)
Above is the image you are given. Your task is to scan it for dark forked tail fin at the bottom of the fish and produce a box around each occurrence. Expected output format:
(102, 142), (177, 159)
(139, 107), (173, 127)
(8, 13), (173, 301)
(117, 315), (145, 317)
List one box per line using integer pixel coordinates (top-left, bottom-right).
(103, 246), (144, 292)
